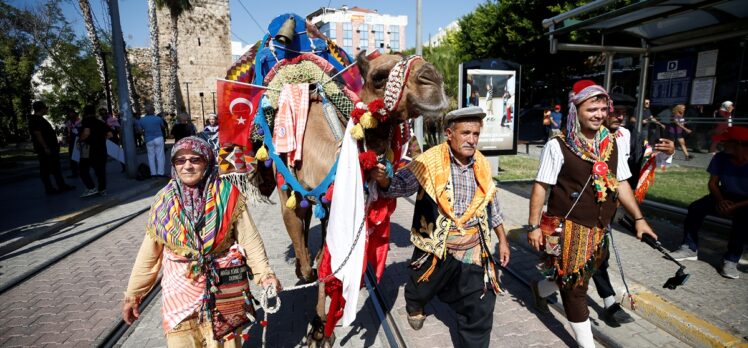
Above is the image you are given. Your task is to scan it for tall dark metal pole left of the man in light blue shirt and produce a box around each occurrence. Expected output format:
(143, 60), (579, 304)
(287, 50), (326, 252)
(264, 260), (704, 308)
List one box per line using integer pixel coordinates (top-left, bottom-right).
(109, 0), (136, 178)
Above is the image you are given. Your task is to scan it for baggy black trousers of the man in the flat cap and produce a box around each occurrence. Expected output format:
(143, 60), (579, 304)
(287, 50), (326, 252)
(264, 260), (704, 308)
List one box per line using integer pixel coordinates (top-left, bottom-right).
(405, 248), (496, 348)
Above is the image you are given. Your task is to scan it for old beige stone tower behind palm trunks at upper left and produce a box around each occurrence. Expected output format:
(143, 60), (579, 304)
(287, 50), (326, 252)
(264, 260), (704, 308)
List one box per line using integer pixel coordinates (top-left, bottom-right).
(158, 0), (231, 131)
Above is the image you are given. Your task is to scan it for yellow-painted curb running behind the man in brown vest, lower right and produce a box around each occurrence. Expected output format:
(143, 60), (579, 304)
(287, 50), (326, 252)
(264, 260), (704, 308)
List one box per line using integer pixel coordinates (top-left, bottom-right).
(506, 227), (748, 348)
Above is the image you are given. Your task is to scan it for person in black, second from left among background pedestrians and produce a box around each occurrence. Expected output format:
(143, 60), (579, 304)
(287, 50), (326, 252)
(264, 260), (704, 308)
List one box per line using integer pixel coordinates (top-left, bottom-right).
(78, 106), (112, 198)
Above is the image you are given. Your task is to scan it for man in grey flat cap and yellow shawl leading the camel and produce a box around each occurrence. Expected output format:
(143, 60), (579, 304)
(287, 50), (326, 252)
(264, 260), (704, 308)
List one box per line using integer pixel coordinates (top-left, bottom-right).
(372, 107), (509, 347)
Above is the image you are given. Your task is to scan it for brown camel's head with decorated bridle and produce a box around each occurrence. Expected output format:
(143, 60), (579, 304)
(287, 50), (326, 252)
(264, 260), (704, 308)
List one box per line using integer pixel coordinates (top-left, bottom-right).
(357, 51), (449, 121)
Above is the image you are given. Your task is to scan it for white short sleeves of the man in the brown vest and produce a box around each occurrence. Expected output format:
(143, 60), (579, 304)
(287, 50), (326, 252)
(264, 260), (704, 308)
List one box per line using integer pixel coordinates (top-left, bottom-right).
(535, 136), (631, 185)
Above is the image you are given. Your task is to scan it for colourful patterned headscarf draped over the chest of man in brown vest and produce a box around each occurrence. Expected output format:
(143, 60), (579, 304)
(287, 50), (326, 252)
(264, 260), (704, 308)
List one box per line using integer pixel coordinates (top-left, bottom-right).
(564, 80), (618, 202)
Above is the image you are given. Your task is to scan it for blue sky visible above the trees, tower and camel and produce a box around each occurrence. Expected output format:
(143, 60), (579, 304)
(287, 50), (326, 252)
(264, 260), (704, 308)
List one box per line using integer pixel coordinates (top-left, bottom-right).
(14, 0), (485, 47)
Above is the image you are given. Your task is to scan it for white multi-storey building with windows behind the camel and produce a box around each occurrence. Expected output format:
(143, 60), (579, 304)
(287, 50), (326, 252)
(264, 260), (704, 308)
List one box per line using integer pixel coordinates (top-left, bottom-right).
(307, 6), (408, 55)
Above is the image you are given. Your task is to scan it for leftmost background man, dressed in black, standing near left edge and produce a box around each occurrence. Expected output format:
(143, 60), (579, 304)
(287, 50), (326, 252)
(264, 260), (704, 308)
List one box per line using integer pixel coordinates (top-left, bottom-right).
(29, 101), (75, 195)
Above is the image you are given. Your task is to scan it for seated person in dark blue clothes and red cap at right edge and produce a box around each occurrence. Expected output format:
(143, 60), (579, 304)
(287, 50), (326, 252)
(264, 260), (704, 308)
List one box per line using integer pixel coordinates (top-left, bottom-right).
(671, 126), (748, 279)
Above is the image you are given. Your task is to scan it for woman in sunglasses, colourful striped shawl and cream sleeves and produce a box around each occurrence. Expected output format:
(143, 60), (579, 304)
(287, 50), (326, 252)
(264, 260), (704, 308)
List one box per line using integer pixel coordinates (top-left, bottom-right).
(122, 137), (281, 347)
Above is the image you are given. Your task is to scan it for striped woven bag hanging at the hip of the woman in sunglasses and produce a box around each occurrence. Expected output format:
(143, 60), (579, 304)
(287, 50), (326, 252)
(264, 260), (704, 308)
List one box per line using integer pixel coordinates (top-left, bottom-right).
(206, 243), (257, 341)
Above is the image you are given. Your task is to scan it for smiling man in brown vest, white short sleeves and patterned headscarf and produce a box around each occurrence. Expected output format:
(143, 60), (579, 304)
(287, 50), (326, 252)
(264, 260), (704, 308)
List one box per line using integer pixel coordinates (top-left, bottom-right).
(525, 80), (657, 347)
